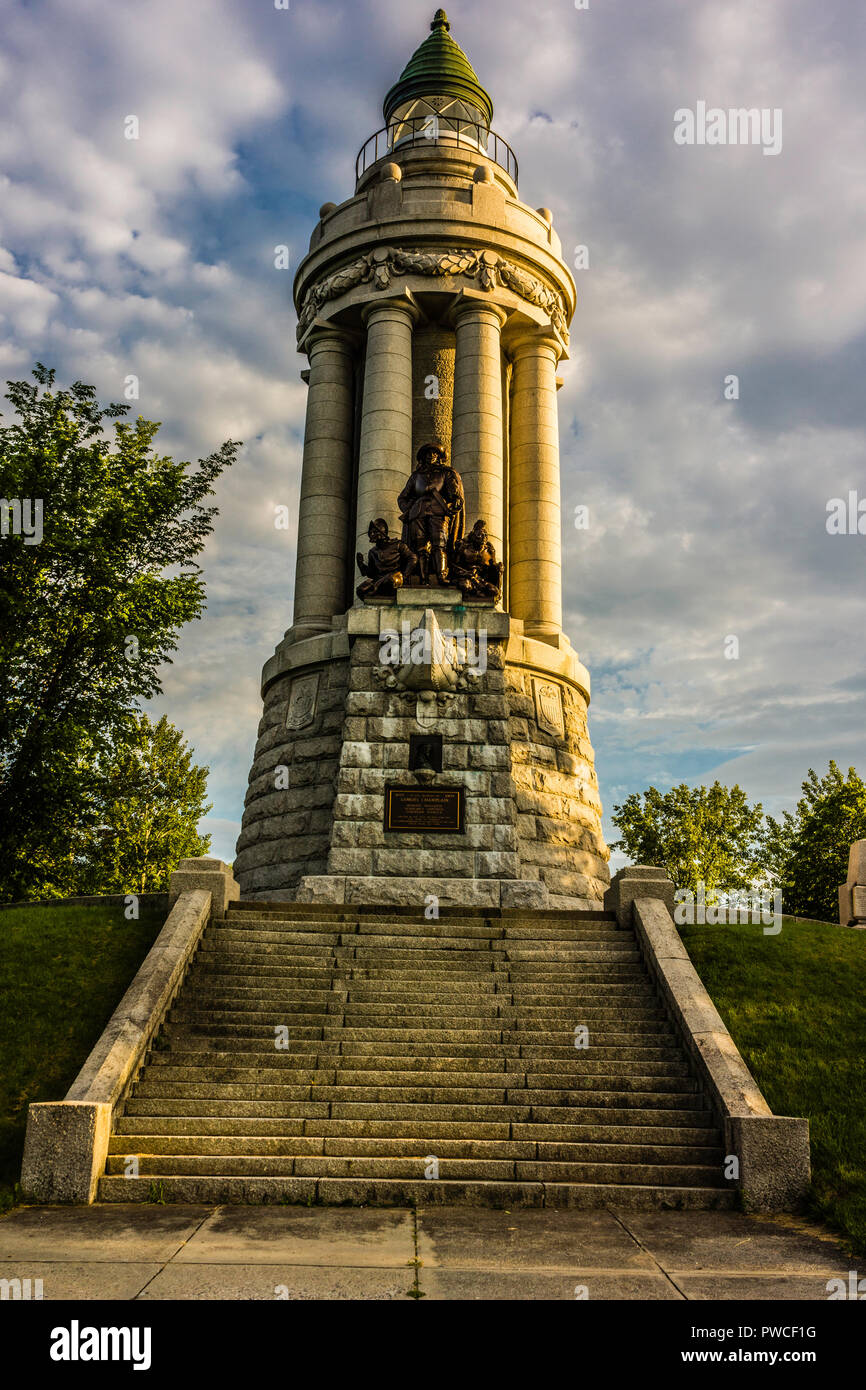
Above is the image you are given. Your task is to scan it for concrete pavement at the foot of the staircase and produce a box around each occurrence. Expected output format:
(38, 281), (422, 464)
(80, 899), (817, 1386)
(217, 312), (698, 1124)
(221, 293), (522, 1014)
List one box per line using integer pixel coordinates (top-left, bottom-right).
(0, 1204), (852, 1300)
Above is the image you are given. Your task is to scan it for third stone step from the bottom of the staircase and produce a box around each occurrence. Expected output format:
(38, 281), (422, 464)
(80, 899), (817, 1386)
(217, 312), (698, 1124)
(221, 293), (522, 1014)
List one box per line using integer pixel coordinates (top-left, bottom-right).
(108, 1133), (724, 1176)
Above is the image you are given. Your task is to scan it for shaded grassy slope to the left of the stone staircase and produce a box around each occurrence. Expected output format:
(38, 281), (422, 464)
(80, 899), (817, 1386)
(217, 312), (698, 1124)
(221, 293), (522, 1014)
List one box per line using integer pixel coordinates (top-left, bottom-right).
(0, 898), (165, 1211)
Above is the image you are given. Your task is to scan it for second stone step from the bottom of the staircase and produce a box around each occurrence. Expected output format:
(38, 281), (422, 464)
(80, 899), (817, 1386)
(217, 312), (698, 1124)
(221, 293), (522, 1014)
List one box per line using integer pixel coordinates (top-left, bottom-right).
(106, 1154), (724, 1187)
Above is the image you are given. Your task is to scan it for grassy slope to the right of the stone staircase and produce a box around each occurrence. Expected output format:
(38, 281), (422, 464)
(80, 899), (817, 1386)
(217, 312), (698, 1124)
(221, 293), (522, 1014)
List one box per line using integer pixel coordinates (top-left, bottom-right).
(680, 917), (866, 1255)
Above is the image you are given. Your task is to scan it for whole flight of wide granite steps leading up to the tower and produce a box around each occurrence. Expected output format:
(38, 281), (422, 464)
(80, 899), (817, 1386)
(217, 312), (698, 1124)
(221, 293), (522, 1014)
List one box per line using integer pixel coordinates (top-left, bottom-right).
(99, 902), (735, 1208)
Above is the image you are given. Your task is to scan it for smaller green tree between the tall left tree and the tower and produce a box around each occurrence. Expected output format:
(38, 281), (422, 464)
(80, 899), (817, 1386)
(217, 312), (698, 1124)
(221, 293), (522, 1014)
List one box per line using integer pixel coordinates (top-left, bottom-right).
(78, 714), (211, 892)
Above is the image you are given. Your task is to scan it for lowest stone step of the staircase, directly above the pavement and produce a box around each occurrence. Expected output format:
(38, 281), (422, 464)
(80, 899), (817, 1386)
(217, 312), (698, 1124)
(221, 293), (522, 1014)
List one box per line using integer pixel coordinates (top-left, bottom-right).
(99, 1176), (737, 1211)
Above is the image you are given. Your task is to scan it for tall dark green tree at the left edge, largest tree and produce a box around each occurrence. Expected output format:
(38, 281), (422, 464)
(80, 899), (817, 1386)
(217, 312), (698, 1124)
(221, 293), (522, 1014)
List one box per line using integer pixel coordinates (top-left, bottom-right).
(0, 364), (239, 899)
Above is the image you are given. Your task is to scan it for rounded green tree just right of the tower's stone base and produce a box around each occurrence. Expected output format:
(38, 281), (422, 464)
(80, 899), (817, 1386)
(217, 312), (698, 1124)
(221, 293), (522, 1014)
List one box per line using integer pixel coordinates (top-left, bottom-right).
(610, 781), (763, 901)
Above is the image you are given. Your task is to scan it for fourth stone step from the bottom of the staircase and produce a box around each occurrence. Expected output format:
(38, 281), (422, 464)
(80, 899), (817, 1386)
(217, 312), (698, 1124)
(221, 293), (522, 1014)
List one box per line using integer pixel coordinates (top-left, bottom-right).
(111, 1115), (720, 1145)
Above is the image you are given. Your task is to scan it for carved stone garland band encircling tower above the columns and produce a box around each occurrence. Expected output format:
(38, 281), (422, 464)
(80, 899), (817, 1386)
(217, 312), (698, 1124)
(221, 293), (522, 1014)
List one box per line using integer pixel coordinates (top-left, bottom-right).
(297, 246), (569, 343)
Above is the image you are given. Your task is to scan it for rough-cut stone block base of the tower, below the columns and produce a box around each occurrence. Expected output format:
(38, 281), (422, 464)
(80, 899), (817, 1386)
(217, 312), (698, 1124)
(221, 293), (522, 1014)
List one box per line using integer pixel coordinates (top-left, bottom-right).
(234, 594), (609, 908)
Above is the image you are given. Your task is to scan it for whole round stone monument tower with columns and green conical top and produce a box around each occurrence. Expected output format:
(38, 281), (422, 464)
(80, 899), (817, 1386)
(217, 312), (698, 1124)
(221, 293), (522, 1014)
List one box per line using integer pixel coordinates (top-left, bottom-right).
(235, 10), (609, 908)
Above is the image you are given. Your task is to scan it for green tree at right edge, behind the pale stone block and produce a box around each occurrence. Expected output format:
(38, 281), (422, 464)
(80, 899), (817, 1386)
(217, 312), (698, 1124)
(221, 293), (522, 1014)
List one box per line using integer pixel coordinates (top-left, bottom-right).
(765, 759), (866, 922)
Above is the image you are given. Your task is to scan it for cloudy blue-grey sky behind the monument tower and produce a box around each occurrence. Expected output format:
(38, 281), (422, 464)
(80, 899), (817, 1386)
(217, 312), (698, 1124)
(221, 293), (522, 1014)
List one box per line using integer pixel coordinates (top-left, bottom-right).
(0, 0), (866, 859)
